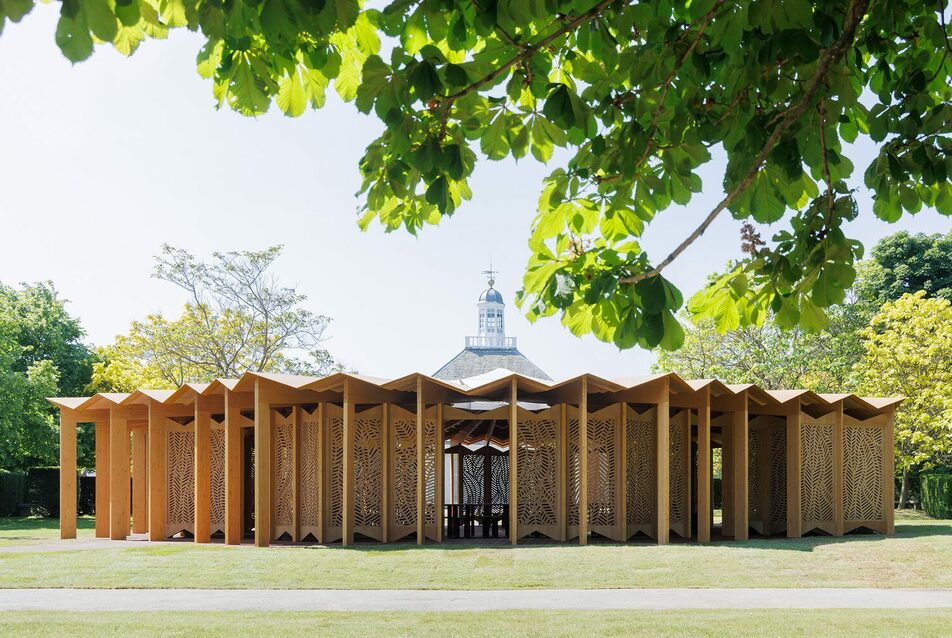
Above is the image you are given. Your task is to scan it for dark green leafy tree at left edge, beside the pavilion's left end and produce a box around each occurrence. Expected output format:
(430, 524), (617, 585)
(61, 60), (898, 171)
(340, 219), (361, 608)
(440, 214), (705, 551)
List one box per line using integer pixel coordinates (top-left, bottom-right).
(0, 282), (94, 469)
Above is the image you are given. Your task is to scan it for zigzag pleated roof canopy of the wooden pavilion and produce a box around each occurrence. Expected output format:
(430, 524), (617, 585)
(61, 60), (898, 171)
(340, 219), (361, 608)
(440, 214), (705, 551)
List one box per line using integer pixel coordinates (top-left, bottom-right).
(48, 368), (903, 413)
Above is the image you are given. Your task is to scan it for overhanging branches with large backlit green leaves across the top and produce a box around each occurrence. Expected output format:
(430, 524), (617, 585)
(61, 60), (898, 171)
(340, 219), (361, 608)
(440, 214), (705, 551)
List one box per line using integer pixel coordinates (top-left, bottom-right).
(0, 0), (952, 350)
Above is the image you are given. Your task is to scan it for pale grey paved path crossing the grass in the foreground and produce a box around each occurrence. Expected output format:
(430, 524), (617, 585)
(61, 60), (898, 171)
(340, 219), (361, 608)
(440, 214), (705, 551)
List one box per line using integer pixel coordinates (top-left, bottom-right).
(0, 588), (952, 611)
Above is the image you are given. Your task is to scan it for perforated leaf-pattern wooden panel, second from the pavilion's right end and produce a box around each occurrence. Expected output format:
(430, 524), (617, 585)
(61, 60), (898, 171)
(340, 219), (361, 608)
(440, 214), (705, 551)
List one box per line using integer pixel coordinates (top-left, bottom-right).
(800, 423), (833, 532)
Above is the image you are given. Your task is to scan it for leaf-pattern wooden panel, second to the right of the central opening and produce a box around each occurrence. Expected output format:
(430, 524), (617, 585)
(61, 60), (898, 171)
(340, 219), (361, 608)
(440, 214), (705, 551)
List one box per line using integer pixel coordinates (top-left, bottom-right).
(588, 406), (619, 528)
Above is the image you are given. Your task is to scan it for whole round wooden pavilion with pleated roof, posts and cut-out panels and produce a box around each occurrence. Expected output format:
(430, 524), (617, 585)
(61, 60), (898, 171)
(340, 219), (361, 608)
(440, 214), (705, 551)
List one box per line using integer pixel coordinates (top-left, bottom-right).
(50, 370), (900, 546)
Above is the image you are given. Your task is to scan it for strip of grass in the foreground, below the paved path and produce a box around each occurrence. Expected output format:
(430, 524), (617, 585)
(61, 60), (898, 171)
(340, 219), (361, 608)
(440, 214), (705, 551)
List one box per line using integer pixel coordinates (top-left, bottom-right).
(0, 609), (952, 638)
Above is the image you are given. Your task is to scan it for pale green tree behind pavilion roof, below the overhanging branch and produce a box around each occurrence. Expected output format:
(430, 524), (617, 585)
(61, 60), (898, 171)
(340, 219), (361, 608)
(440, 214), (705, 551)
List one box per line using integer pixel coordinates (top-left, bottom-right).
(653, 290), (867, 392)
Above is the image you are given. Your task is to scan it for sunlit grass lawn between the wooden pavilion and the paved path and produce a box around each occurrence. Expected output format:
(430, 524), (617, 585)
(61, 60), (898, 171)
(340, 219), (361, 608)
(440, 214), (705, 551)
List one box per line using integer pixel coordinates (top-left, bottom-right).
(0, 512), (952, 592)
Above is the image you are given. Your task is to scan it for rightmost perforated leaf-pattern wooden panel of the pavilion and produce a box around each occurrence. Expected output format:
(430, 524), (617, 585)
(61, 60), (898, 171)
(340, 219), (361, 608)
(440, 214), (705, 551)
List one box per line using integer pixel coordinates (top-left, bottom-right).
(843, 425), (884, 521)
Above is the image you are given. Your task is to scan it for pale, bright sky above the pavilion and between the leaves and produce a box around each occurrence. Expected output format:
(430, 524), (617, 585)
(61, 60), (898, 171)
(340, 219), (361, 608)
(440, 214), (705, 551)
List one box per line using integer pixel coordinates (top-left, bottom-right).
(0, 4), (952, 379)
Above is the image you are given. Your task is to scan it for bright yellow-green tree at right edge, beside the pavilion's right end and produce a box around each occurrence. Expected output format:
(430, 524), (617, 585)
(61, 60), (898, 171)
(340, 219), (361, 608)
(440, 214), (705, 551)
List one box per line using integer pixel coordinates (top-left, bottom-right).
(857, 290), (952, 507)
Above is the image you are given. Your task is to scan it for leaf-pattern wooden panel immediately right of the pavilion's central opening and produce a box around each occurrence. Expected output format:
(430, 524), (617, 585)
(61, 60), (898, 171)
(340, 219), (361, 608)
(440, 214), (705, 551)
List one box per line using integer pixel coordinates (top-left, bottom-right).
(516, 407), (560, 527)
